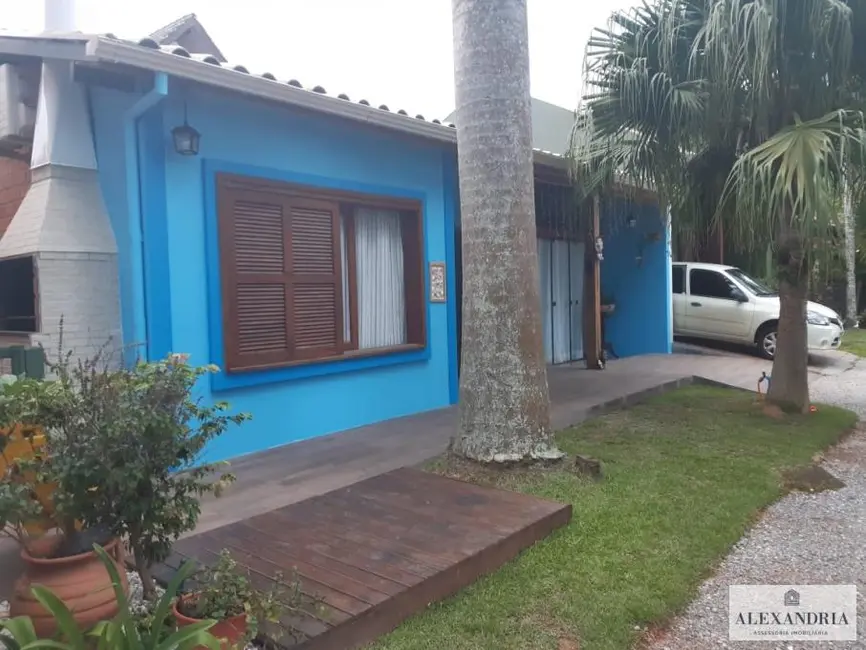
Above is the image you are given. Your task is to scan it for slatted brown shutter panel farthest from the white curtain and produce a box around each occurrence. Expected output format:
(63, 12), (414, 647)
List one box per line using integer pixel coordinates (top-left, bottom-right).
(219, 188), (292, 371)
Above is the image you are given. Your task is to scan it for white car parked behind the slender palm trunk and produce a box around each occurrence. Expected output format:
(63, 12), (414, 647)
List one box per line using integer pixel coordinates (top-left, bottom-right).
(672, 262), (844, 359)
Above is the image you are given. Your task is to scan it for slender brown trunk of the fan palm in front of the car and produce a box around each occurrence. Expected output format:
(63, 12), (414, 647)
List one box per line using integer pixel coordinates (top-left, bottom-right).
(767, 211), (809, 413)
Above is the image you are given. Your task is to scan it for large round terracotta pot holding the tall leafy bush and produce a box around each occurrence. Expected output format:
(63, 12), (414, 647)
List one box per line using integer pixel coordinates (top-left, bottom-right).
(9, 536), (129, 638)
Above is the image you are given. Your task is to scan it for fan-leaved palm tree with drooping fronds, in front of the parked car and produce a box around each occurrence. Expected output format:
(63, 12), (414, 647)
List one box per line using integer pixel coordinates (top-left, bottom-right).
(573, 0), (866, 411)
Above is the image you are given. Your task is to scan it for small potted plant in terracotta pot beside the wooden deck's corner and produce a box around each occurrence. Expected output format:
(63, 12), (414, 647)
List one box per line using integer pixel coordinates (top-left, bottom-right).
(173, 549), (301, 648)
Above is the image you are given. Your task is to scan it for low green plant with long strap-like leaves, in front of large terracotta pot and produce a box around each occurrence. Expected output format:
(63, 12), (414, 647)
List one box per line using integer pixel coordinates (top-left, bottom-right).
(0, 546), (220, 650)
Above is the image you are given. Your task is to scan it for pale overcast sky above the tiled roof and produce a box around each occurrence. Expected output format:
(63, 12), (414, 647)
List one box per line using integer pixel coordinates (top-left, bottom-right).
(0, 0), (638, 118)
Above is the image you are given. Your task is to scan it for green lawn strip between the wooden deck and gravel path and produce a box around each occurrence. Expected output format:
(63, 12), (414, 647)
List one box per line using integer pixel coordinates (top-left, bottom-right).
(372, 387), (856, 650)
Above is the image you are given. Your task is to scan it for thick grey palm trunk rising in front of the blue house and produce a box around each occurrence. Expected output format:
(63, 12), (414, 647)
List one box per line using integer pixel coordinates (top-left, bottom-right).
(452, 0), (562, 462)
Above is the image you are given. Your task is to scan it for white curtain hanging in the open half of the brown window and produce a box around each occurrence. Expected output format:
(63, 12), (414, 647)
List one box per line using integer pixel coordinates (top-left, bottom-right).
(355, 208), (406, 350)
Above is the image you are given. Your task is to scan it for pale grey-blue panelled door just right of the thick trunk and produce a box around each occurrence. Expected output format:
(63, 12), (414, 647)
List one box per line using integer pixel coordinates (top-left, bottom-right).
(538, 239), (584, 363)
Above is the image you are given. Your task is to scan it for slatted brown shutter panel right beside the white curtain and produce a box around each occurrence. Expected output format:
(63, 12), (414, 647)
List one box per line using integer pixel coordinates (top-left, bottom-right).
(289, 197), (343, 360)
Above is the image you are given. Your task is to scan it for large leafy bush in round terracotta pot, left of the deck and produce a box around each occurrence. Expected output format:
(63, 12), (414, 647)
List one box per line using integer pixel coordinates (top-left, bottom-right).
(0, 341), (248, 635)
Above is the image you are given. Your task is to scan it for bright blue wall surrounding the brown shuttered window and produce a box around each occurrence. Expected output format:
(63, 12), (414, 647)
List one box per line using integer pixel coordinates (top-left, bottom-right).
(94, 87), (456, 460)
